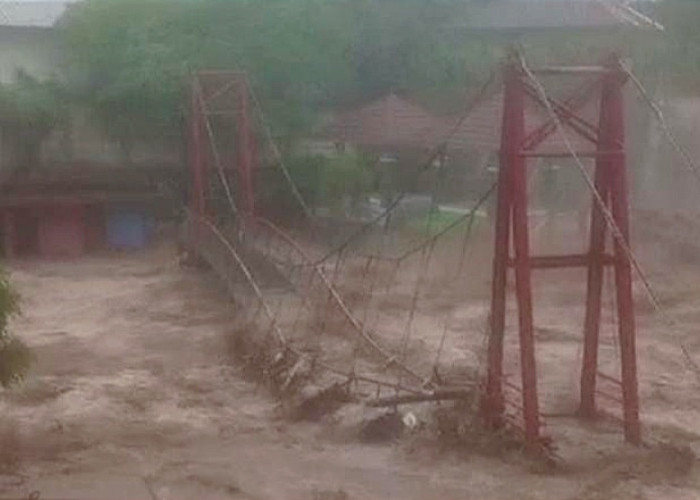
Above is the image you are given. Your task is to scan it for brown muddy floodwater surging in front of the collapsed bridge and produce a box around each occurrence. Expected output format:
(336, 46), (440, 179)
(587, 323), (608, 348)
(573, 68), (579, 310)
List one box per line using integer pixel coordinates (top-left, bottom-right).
(0, 240), (700, 500)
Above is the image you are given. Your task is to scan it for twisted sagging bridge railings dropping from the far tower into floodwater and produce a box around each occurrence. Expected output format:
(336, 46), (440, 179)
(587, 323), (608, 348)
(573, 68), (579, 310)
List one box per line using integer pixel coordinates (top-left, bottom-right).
(185, 209), (431, 394)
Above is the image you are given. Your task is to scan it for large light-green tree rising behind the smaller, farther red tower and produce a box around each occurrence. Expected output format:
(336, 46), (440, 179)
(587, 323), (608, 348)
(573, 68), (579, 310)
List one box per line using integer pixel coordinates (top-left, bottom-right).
(63, 0), (347, 157)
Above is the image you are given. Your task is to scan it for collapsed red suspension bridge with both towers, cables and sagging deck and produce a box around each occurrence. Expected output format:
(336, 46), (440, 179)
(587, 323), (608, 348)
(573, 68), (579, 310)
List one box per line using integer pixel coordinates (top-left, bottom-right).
(187, 54), (697, 456)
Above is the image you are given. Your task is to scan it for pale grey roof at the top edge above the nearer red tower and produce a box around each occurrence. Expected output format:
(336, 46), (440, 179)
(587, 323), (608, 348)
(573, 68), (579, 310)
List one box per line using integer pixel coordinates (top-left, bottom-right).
(466, 0), (662, 31)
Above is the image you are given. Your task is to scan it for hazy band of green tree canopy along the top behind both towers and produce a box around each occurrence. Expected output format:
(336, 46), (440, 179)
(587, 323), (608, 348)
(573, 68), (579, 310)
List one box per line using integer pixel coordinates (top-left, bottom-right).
(47, 0), (700, 156)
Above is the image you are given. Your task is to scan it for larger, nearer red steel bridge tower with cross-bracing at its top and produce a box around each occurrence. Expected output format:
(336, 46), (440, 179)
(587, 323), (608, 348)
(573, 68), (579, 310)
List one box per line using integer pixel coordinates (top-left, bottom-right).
(482, 53), (641, 446)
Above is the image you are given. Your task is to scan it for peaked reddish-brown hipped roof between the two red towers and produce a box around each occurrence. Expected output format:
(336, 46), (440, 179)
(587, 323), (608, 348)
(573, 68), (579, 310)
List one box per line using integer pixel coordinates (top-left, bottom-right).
(326, 94), (449, 148)
